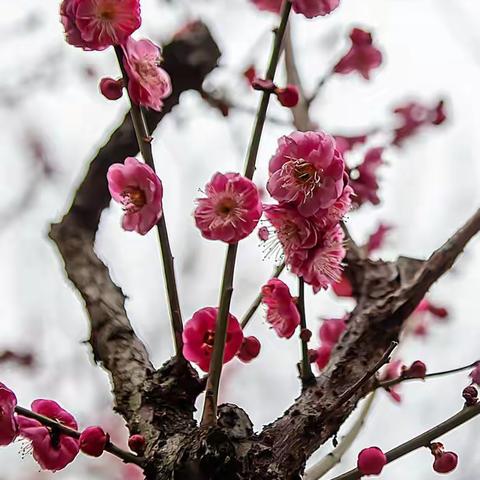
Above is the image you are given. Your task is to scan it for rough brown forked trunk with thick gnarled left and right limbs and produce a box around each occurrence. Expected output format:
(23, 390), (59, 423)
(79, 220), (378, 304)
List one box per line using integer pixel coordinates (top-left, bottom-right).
(47, 17), (480, 480)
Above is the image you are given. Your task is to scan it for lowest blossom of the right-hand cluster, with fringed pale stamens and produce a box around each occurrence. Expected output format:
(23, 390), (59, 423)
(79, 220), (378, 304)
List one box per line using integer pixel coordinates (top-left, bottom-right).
(290, 225), (346, 293)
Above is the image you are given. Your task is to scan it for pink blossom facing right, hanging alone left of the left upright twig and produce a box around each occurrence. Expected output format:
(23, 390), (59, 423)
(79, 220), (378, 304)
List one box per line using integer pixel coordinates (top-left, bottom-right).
(107, 157), (163, 235)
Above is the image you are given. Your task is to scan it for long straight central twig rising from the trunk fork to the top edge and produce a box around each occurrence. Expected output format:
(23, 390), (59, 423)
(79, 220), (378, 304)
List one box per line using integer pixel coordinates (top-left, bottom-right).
(201, 0), (292, 426)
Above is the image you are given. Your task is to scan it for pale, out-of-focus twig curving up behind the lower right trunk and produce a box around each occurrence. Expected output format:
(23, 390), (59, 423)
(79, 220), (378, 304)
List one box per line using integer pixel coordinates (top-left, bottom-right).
(303, 392), (376, 480)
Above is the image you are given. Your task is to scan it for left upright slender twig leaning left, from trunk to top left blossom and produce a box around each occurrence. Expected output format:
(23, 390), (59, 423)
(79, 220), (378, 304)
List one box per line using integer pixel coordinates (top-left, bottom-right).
(115, 47), (183, 359)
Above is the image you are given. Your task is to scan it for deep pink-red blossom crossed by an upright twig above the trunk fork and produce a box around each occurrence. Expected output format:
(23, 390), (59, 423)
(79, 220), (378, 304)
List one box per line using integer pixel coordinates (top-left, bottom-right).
(183, 307), (243, 372)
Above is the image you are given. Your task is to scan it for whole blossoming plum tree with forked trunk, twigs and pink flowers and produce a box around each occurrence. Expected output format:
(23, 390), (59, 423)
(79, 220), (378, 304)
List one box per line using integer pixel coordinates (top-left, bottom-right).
(0, 0), (480, 480)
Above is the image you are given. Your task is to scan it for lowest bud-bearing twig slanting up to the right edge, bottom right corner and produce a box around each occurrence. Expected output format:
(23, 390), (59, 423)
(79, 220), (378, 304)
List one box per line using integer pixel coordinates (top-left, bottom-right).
(332, 403), (480, 480)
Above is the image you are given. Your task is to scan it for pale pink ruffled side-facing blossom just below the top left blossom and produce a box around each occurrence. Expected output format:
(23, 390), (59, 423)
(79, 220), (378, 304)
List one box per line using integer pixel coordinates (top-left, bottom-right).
(123, 37), (172, 111)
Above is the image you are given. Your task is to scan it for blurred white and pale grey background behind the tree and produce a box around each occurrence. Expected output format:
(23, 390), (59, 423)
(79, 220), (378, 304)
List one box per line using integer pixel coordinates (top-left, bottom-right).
(0, 0), (480, 480)
